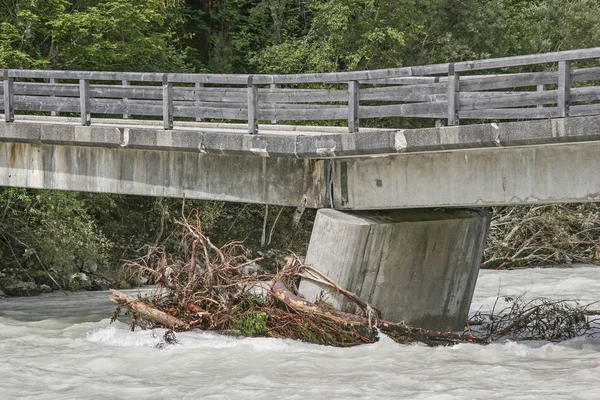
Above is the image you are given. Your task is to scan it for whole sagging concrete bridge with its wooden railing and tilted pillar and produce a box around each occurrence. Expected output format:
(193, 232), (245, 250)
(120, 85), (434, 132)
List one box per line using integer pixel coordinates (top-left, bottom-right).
(0, 48), (600, 329)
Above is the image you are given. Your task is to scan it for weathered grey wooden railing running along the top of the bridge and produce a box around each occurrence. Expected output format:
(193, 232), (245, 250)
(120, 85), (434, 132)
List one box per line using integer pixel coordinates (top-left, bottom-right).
(0, 48), (600, 134)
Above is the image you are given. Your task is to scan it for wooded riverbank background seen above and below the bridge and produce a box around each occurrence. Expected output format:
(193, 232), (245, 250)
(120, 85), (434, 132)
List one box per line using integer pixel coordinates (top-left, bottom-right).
(0, 0), (600, 295)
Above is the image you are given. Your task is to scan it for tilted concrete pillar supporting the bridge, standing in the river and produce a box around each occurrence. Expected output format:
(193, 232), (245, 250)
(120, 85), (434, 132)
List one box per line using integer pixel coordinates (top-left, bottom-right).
(299, 209), (490, 331)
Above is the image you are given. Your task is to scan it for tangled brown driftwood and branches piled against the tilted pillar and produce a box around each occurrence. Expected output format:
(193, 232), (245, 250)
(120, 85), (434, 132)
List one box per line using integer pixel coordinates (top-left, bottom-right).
(111, 205), (595, 347)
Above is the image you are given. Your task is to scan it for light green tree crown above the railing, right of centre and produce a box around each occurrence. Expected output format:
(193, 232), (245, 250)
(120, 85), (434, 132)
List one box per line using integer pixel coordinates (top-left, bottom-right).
(252, 0), (424, 73)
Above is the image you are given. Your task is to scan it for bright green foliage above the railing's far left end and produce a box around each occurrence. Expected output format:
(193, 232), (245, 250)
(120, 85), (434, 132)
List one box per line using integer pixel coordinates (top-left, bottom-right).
(0, 0), (187, 71)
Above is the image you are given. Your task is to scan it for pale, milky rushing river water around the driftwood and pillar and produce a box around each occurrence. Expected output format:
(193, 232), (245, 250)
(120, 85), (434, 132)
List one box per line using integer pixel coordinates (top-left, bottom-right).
(0, 267), (600, 400)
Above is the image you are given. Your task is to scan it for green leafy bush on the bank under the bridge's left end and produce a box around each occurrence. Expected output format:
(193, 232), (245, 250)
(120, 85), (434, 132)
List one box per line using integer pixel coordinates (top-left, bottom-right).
(0, 188), (111, 274)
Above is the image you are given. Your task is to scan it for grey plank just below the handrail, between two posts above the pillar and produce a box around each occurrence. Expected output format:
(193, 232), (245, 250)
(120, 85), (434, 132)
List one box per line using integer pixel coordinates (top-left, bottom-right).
(360, 83), (448, 102)
